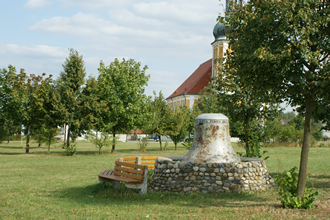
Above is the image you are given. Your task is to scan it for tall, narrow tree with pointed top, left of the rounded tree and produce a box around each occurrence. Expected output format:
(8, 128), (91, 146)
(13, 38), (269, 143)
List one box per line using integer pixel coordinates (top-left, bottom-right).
(56, 49), (86, 148)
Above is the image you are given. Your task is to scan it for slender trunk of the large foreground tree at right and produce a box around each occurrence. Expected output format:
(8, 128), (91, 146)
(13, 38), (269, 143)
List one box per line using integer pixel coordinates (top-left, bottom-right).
(297, 95), (313, 198)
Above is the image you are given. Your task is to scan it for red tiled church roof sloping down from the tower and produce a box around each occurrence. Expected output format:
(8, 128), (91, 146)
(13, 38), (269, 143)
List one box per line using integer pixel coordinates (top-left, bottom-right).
(166, 59), (212, 99)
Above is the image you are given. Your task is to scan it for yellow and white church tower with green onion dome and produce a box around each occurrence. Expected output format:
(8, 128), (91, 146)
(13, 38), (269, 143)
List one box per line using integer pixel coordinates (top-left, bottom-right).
(211, 22), (229, 77)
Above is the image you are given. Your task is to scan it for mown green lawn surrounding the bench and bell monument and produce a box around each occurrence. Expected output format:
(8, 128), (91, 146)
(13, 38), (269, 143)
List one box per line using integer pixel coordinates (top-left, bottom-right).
(0, 142), (330, 219)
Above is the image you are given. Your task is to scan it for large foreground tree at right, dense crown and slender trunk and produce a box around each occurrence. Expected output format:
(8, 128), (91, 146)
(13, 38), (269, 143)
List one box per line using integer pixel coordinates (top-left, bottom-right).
(225, 0), (330, 197)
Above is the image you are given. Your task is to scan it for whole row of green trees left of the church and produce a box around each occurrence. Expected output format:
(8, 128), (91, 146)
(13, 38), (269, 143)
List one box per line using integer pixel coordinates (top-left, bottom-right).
(0, 49), (149, 153)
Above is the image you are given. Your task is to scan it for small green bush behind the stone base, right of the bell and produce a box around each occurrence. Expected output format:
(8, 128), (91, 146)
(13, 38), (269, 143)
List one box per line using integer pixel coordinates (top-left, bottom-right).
(237, 134), (269, 160)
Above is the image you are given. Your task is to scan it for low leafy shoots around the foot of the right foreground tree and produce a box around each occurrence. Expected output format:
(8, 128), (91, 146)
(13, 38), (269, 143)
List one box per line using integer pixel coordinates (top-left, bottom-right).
(276, 167), (320, 209)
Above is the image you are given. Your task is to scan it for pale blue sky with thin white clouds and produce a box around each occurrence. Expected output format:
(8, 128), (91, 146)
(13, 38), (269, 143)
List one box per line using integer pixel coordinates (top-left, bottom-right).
(0, 0), (225, 97)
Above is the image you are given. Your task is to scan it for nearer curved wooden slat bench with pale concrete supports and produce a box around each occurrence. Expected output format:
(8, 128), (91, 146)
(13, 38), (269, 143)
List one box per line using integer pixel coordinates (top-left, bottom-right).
(98, 158), (148, 194)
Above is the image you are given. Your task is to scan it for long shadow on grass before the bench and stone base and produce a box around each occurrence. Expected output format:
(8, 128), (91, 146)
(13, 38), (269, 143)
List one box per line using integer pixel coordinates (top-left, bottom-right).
(54, 180), (269, 208)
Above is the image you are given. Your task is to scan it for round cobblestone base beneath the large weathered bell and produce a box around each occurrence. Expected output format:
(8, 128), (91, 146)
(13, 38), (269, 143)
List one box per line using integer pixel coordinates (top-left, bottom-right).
(148, 157), (274, 193)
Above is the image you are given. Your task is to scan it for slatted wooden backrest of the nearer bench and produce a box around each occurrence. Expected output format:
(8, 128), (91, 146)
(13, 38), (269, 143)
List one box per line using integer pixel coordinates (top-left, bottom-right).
(114, 161), (146, 183)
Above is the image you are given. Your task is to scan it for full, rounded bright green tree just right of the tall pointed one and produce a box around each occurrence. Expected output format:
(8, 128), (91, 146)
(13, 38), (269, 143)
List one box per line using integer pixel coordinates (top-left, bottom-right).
(97, 59), (149, 153)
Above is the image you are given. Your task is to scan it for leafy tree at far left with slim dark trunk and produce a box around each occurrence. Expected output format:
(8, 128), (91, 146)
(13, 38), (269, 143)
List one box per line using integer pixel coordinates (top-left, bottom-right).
(2, 66), (52, 153)
